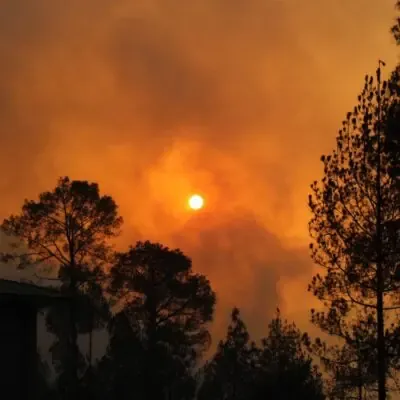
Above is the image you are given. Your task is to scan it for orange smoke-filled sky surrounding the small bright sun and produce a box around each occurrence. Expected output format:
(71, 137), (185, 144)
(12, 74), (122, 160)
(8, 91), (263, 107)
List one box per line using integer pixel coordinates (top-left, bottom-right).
(0, 0), (397, 342)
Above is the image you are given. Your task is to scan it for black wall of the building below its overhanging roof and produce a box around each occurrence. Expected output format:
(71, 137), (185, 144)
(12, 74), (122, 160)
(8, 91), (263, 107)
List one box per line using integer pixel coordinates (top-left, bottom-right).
(0, 301), (37, 400)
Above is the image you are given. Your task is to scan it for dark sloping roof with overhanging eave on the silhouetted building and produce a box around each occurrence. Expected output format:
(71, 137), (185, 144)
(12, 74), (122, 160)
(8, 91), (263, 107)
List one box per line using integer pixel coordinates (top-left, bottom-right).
(0, 279), (66, 308)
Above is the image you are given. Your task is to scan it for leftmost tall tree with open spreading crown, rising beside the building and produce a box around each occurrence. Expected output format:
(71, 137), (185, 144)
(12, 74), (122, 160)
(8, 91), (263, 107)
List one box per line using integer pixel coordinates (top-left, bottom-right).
(2, 177), (122, 398)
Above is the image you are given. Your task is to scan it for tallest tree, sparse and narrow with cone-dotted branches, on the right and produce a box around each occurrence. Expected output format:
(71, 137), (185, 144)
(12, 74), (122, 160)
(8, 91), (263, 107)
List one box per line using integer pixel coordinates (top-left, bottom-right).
(309, 62), (400, 400)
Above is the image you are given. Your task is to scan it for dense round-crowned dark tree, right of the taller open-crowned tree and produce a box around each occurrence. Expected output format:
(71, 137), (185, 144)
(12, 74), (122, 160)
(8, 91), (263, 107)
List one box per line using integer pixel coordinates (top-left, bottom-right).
(108, 241), (215, 400)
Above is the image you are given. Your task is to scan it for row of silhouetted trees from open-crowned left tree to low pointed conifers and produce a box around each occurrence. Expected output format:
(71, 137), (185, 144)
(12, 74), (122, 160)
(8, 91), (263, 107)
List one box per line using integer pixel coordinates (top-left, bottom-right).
(1, 177), (324, 400)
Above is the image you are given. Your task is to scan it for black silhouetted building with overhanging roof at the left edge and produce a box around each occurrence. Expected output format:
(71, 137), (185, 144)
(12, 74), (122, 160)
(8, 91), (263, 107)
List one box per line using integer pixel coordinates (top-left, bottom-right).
(0, 279), (64, 400)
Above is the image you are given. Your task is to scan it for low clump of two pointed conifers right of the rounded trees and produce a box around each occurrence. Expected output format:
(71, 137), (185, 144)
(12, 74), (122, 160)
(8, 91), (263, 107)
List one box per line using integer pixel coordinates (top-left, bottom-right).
(198, 308), (324, 400)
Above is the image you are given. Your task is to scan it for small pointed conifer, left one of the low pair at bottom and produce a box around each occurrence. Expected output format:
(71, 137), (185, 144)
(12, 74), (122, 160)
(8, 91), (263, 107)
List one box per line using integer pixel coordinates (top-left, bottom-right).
(198, 308), (259, 400)
